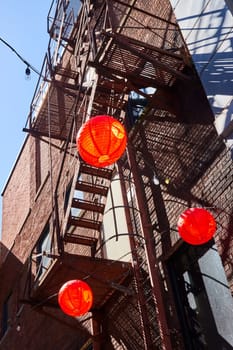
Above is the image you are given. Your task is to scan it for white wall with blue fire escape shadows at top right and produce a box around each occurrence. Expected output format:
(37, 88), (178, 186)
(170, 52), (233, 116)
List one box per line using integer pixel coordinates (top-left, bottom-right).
(170, 0), (233, 152)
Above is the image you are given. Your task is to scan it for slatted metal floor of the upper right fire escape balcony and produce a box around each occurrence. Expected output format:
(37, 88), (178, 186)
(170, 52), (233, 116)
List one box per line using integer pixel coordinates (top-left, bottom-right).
(93, 33), (188, 87)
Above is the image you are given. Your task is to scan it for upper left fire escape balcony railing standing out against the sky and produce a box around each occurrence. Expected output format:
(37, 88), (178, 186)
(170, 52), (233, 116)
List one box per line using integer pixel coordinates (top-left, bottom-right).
(24, 1), (83, 139)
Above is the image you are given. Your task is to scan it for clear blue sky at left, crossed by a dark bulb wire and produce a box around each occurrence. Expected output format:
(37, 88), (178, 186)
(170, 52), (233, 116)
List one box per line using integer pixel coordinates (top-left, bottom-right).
(0, 0), (52, 231)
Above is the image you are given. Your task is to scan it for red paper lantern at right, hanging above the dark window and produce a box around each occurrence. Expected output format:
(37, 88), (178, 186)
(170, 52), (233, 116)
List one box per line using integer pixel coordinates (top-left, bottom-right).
(178, 208), (216, 245)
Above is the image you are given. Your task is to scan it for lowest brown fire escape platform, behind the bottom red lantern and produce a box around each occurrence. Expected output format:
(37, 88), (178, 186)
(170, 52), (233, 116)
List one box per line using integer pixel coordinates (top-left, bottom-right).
(30, 254), (131, 309)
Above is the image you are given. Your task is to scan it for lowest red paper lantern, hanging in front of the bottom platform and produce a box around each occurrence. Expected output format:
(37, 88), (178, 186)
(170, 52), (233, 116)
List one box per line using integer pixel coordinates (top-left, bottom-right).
(58, 280), (93, 316)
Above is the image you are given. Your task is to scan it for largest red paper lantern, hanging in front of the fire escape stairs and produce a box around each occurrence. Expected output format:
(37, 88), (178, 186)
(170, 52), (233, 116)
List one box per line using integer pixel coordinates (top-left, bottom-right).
(76, 115), (127, 167)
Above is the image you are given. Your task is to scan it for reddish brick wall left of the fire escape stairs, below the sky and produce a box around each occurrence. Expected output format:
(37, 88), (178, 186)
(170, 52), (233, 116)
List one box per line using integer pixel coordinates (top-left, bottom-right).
(0, 132), (90, 350)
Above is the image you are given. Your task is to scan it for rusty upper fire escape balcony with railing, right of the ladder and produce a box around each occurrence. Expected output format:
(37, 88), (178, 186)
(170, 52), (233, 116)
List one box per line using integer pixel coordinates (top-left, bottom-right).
(90, 1), (188, 89)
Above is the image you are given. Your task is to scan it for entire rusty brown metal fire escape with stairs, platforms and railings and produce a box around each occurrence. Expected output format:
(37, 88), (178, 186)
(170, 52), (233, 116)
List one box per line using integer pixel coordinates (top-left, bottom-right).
(22, 0), (194, 349)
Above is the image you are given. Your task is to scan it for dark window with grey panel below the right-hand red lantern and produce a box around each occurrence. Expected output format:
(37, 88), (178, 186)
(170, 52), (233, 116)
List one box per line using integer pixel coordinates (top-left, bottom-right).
(169, 244), (233, 350)
